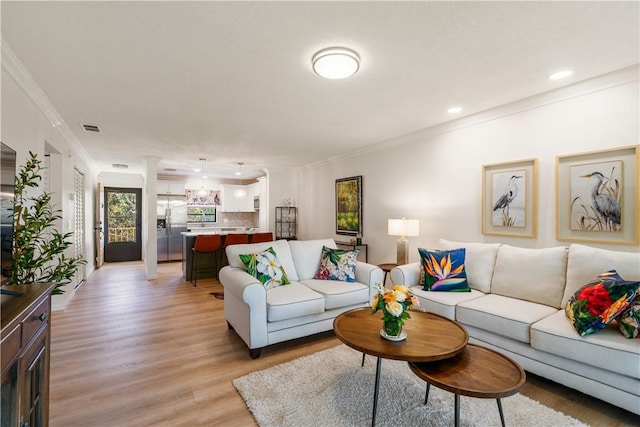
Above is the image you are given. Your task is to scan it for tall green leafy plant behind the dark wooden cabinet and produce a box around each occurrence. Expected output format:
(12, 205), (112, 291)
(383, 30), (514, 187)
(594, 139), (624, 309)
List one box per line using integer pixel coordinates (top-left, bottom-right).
(8, 151), (86, 295)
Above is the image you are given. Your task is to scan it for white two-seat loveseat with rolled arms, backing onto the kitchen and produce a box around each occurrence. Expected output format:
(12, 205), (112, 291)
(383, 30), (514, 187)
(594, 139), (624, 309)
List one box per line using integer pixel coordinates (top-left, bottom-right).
(219, 239), (383, 359)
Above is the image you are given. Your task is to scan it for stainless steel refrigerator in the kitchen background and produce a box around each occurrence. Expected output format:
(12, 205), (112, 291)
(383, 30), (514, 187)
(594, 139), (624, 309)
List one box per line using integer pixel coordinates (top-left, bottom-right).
(157, 195), (187, 262)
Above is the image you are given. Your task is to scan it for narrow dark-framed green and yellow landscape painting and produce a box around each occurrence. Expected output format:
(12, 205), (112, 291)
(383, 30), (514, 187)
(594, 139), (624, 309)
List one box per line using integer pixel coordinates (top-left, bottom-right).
(336, 175), (362, 236)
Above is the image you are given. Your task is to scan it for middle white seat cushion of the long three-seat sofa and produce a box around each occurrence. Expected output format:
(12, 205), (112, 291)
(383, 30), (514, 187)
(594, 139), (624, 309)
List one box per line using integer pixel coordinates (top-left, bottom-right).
(456, 294), (558, 343)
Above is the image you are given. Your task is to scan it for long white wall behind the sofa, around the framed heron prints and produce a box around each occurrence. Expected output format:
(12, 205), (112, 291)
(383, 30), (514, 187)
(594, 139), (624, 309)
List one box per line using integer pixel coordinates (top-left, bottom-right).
(298, 67), (640, 264)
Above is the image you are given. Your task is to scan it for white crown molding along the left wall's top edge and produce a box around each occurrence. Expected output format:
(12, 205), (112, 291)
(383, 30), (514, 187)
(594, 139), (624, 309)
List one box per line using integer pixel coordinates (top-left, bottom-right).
(2, 37), (94, 169)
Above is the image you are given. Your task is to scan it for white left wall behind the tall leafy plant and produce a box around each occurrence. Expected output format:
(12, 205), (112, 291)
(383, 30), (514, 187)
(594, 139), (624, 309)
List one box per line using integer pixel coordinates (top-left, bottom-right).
(0, 63), (96, 310)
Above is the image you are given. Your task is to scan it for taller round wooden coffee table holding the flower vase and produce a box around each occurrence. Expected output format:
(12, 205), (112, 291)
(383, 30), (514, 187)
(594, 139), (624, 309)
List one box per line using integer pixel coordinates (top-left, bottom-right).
(333, 308), (469, 425)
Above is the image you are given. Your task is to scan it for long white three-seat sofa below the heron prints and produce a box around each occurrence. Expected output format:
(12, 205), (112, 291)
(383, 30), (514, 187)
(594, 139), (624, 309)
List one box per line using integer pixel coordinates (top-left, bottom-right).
(391, 240), (640, 414)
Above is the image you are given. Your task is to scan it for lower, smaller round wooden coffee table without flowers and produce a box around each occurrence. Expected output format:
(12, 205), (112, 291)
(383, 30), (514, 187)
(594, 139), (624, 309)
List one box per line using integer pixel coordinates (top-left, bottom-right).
(409, 344), (526, 427)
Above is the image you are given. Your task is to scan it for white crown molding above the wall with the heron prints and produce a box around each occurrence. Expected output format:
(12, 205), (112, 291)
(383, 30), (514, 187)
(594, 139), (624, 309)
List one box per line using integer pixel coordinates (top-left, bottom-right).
(301, 64), (640, 169)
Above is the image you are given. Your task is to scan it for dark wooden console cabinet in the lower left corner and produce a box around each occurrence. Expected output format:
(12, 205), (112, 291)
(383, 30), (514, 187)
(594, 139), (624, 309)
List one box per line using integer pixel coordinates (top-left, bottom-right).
(0, 284), (53, 427)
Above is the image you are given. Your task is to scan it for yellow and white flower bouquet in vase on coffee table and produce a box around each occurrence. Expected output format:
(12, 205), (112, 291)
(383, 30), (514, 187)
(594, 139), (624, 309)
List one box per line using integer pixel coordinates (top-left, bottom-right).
(371, 283), (420, 341)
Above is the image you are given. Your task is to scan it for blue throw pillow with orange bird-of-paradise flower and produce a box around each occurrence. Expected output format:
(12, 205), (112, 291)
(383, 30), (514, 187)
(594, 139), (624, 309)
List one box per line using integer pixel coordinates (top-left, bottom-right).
(418, 248), (471, 292)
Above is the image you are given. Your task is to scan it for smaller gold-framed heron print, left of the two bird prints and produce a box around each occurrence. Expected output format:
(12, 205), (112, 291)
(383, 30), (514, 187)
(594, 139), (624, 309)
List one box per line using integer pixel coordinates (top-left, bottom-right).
(482, 159), (538, 237)
